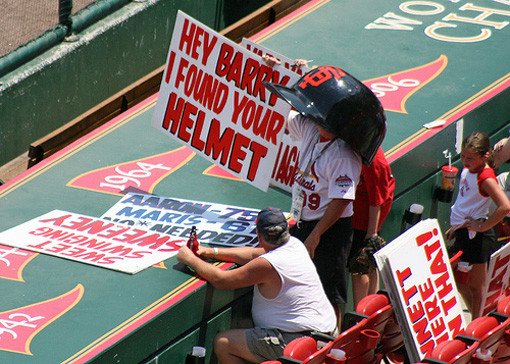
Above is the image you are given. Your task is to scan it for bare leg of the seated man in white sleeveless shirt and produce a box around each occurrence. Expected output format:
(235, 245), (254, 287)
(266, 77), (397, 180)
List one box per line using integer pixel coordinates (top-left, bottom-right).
(214, 329), (258, 364)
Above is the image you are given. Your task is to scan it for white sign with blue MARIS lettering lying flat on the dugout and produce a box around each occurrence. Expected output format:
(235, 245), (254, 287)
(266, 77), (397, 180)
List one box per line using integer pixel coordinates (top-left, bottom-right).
(102, 193), (259, 246)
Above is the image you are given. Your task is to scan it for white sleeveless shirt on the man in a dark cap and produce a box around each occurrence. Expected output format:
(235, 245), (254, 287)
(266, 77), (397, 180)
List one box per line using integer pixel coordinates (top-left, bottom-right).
(252, 237), (336, 332)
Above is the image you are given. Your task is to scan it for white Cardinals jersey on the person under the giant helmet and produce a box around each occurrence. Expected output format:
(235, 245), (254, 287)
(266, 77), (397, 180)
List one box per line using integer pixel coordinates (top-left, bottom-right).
(287, 111), (361, 221)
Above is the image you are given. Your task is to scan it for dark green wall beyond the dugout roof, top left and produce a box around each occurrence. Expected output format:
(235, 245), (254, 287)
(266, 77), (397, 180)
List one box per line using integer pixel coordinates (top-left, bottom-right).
(0, 0), (268, 165)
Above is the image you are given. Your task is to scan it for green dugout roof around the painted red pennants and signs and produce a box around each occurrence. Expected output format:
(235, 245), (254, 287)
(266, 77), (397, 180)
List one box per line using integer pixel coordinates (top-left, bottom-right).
(0, 1), (510, 363)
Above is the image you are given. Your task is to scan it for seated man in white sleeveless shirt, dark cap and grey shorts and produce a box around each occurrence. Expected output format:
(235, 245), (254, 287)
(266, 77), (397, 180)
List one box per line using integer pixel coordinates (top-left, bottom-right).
(177, 208), (336, 364)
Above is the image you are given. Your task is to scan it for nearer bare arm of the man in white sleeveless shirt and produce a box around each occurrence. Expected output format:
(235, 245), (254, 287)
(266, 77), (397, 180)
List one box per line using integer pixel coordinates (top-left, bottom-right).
(177, 246), (278, 290)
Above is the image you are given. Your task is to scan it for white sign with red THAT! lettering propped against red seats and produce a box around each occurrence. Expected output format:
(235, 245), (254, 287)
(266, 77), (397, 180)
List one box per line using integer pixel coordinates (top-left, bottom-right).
(375, 219), (466, 362)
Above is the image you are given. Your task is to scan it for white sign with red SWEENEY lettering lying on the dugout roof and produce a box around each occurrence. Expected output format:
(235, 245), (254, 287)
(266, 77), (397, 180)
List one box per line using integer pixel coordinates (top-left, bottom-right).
(0, 210), (186, 274)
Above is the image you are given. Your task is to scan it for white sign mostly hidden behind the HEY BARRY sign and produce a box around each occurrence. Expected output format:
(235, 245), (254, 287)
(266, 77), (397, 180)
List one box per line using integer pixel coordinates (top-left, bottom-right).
(241, 38), (304, 192)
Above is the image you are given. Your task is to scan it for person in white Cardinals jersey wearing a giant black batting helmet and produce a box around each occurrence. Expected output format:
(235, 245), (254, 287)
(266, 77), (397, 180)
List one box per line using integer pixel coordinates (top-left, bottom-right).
(264, 66), (386, 328)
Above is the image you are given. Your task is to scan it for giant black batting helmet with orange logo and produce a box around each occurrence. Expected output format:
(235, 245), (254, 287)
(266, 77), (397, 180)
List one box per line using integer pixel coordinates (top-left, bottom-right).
(264, 66), (386, 164)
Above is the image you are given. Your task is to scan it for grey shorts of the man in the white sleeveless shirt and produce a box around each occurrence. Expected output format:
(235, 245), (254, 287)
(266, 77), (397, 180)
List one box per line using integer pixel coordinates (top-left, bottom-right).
(245, 327), (309, 361)
